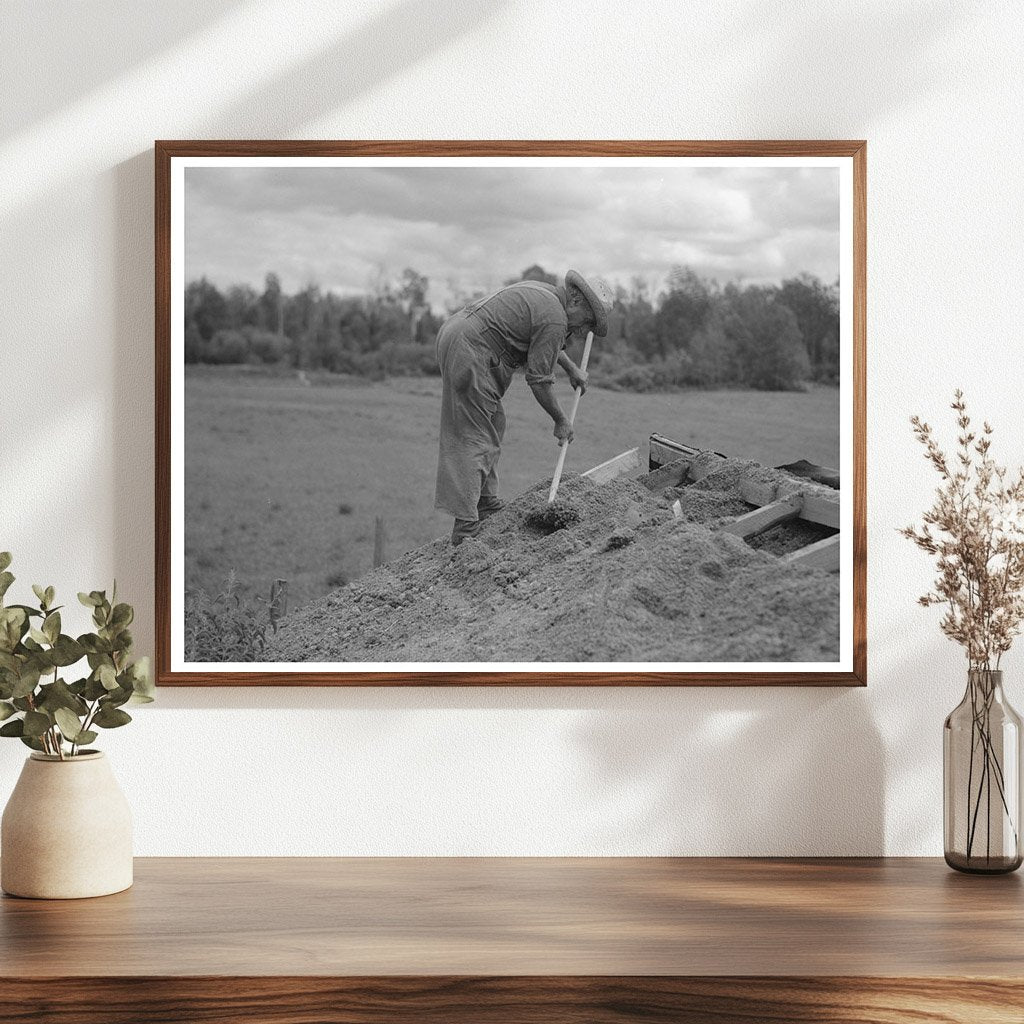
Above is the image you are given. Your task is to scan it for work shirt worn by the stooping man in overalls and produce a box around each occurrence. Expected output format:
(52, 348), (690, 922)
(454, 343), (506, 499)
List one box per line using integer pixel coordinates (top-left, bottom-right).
(466, 281), (568, 385)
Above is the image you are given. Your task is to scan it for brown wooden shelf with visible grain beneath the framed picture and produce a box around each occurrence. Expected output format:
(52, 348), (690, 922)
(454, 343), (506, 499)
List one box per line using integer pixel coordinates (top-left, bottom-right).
(0, 858), (1024, 1024)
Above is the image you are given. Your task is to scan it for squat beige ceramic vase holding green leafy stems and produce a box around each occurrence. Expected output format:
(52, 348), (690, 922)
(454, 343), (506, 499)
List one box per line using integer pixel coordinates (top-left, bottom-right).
(0, 751), (132, 899)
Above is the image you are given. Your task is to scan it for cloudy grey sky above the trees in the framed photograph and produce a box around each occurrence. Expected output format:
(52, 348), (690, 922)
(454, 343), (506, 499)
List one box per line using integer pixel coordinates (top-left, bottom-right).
(184, 166), (839, 309)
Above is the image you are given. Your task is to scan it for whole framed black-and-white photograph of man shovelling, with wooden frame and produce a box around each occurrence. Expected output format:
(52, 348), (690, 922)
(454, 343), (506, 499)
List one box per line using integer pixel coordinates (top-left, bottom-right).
(156, 141), (866, 686)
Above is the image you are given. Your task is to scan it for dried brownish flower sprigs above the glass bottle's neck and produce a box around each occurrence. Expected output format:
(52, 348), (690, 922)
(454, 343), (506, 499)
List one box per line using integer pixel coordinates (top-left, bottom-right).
(900, 388), (1024, 671)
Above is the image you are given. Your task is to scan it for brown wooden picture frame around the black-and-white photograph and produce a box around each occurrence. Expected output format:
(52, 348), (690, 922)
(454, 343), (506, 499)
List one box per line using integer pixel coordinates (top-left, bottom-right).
(155, 140), (867, 686)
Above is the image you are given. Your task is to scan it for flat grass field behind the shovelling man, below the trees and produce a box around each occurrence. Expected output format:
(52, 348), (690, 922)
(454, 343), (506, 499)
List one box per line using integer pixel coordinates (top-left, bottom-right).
(185, 367), (839, 607)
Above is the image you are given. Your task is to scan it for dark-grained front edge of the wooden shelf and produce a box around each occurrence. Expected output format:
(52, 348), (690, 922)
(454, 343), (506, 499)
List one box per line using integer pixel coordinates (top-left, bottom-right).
(0, 975), (1024, 1024)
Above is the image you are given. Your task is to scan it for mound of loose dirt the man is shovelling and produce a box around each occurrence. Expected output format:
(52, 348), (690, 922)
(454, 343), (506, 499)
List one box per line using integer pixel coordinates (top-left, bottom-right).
(265, 460), (839, 663)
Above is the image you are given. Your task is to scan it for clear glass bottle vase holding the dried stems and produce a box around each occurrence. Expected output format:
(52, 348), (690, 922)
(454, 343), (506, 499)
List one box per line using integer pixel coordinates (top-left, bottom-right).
(942, 669), (1022, 874)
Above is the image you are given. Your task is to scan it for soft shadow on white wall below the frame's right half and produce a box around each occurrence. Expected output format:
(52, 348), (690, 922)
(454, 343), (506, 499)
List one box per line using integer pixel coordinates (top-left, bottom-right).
(573, 687), (886, 856)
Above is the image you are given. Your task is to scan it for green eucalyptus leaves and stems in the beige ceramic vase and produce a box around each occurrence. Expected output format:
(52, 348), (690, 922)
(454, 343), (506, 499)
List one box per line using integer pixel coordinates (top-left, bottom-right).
(0, 551), (154, 760)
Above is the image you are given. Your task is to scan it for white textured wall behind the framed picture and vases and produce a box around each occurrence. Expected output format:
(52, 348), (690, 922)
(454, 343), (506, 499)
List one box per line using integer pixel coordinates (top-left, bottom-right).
(0, 0), (1024, 855)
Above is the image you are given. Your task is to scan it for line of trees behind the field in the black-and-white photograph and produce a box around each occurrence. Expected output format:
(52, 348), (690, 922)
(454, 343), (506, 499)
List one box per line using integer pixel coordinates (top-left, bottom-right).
(184, 265), (840, 391)
